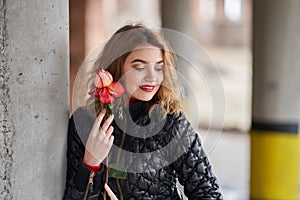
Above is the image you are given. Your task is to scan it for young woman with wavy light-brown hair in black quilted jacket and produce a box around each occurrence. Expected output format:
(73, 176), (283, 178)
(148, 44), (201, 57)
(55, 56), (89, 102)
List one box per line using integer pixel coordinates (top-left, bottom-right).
(64, 24), (222, 200)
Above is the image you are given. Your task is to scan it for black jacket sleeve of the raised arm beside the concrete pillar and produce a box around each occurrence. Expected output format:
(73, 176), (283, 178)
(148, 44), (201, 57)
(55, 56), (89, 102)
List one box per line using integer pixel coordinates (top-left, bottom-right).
(63, 116), (104, 200)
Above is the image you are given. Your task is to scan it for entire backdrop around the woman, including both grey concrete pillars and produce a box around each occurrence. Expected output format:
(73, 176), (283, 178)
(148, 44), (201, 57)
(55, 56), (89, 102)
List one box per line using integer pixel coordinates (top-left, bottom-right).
(0, 0), (300, 200)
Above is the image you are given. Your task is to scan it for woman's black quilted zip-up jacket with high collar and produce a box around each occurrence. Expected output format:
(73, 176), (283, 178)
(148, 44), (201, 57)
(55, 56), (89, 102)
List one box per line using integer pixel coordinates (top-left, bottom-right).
(63, 102), (223, 200)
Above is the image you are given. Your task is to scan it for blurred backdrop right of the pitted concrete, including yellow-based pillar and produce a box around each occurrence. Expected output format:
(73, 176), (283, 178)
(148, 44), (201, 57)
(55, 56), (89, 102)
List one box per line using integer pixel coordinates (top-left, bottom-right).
(70, 0), (300, 200)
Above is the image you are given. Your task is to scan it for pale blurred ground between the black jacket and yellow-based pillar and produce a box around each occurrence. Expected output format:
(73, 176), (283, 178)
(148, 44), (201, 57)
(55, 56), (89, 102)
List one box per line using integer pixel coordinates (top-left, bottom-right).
(177, 131), (250, 200)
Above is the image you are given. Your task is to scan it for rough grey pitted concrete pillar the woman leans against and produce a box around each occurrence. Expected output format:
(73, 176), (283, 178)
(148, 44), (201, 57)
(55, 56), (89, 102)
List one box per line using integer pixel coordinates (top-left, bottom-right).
(0, 0), (69, 200)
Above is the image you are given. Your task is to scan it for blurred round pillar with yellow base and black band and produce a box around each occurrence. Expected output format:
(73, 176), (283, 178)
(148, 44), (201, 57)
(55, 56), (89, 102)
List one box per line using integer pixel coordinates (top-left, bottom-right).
(250, 0), (300, 199)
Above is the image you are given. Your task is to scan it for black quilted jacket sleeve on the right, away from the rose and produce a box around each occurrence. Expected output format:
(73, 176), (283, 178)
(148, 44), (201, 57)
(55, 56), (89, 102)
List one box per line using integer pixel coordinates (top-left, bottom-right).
(173, 113), (223, 199)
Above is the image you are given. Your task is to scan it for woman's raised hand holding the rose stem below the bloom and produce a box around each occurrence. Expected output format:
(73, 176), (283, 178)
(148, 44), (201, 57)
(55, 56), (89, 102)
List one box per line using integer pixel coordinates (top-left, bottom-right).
(83, 109), (114, 166)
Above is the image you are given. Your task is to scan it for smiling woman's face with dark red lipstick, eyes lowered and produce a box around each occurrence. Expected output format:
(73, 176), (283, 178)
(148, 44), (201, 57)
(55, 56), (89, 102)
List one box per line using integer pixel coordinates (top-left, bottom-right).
(122, 44), (164, 101)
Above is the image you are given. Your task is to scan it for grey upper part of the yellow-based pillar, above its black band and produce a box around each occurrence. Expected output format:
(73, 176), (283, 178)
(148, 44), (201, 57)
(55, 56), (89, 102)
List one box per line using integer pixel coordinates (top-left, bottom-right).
(253, 0), (300, 124)
